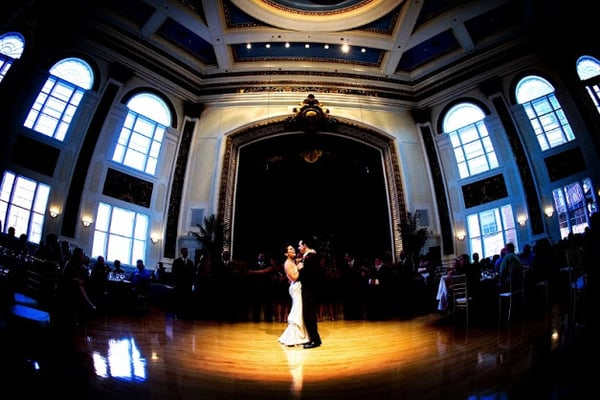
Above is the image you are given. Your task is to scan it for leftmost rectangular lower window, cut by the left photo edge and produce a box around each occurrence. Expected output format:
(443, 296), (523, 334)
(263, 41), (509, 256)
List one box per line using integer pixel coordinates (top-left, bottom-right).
(0, 171), (50, 243)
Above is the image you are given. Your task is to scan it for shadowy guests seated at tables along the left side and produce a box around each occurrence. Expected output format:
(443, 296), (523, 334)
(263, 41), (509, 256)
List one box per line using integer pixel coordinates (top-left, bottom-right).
(0, 227), (167, 326)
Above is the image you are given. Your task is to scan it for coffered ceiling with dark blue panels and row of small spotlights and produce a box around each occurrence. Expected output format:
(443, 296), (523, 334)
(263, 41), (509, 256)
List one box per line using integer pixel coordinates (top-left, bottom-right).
(47, 0), (556, 101)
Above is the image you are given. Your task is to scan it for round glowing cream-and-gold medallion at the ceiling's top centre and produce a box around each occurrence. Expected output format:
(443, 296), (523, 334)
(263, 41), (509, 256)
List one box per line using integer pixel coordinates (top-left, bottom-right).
(231, 0), (404, 32)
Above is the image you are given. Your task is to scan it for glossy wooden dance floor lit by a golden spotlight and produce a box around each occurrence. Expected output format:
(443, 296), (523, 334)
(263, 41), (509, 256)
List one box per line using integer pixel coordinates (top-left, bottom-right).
(1, 309), (596, 400)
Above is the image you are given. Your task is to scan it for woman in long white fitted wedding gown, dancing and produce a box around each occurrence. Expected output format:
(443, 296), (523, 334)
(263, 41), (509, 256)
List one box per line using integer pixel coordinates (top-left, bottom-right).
(279, 245), (309, 346)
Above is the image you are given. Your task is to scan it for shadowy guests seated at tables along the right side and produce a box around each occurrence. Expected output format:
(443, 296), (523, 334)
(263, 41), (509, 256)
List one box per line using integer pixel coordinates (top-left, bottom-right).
(446, 213), (600, 321)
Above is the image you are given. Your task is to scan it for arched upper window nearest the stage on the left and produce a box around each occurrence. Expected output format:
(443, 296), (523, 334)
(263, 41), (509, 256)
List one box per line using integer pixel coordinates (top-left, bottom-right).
(112, 93), (171, 175)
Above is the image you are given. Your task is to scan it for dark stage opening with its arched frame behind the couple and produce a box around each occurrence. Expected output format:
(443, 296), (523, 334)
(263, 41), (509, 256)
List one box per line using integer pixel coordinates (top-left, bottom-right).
(219, 120), (404, 261)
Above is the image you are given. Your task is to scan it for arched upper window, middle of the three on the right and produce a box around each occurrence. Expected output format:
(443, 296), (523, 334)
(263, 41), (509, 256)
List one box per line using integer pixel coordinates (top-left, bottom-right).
(516, 75), (575, 151)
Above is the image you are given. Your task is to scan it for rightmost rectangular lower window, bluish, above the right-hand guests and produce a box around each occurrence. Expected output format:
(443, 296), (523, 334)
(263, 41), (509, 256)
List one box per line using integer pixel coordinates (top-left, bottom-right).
(552, 178), (598, 239)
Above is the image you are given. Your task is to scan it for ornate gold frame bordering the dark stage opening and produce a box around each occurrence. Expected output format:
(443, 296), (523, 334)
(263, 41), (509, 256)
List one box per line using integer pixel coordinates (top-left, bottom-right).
(218, 107), (406, 259)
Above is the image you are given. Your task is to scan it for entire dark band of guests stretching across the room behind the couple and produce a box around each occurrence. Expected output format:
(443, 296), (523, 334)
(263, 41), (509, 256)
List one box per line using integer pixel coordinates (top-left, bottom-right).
(0, 209), (598, 328)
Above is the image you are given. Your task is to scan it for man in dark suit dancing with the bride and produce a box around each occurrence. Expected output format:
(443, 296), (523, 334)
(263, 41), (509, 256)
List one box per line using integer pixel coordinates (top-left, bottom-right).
(298, 240), (321, 349)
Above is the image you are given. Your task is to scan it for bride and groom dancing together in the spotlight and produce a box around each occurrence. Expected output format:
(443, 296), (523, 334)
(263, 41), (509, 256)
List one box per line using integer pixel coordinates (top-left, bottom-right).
(279, 240), (321, 349)
